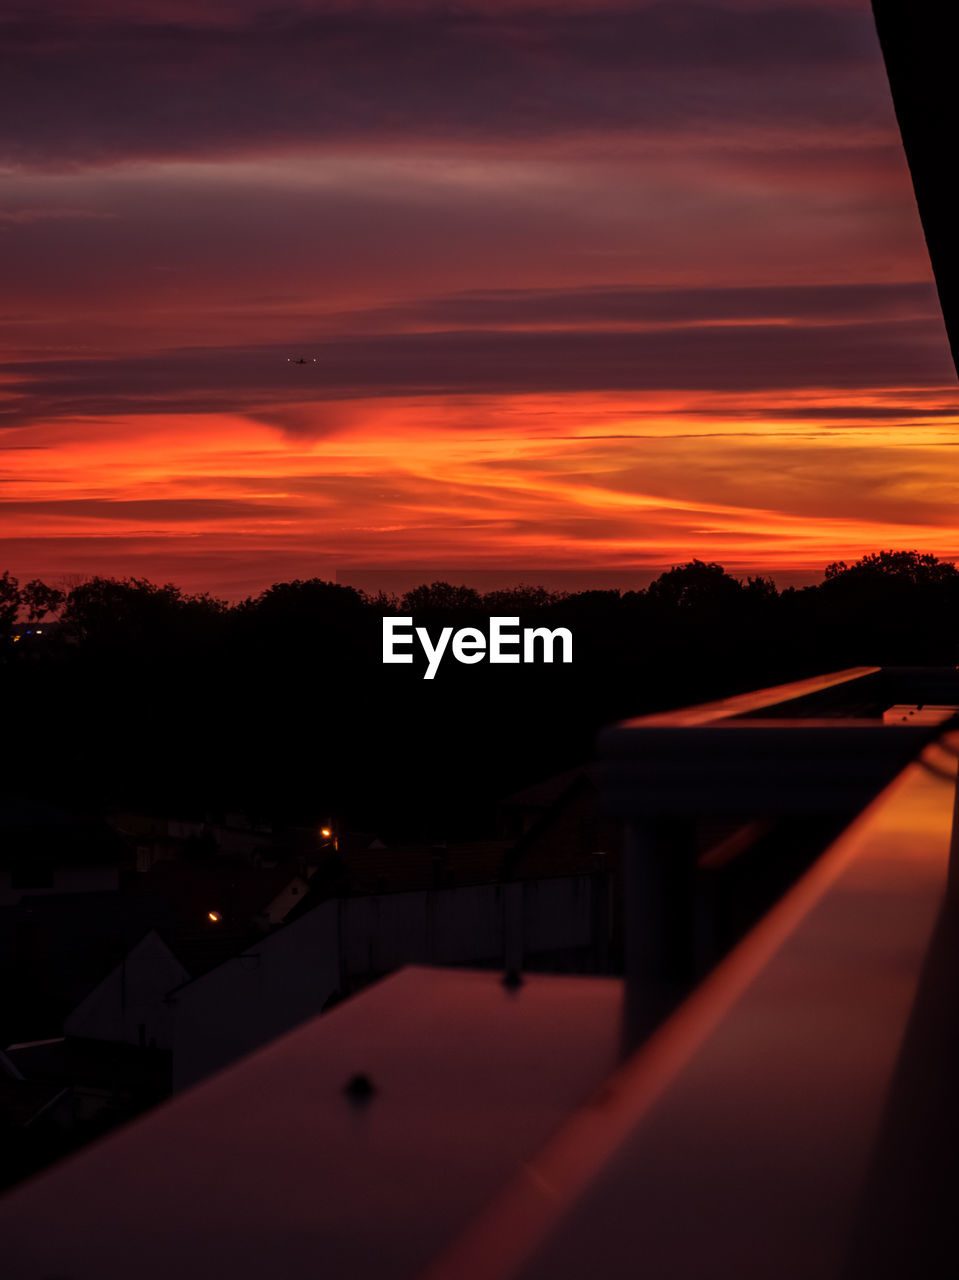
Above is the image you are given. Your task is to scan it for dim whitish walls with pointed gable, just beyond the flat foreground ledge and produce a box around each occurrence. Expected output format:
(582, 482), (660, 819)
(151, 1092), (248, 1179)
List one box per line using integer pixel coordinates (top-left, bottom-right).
(64, 876), (594, 1089)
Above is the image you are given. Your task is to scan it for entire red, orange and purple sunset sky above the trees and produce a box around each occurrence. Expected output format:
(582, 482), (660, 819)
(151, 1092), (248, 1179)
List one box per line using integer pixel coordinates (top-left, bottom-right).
(0, 0), (959, 599)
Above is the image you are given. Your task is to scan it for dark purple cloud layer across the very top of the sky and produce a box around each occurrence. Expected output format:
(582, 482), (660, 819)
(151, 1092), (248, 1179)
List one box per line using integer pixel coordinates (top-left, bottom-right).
(0, 0), (891, 166)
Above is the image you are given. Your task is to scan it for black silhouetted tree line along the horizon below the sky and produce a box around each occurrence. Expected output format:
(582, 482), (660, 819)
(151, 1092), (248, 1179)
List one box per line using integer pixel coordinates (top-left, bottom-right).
(0, 550), (959, 838)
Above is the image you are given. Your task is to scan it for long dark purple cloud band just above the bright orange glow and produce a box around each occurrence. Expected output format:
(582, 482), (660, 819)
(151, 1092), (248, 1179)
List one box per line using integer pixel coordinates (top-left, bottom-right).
(0, 309), (954, 434)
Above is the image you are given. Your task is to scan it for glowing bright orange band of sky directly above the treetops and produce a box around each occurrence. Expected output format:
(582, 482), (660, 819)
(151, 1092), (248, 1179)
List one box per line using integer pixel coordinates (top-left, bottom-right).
(7, 388), (959, 598)
